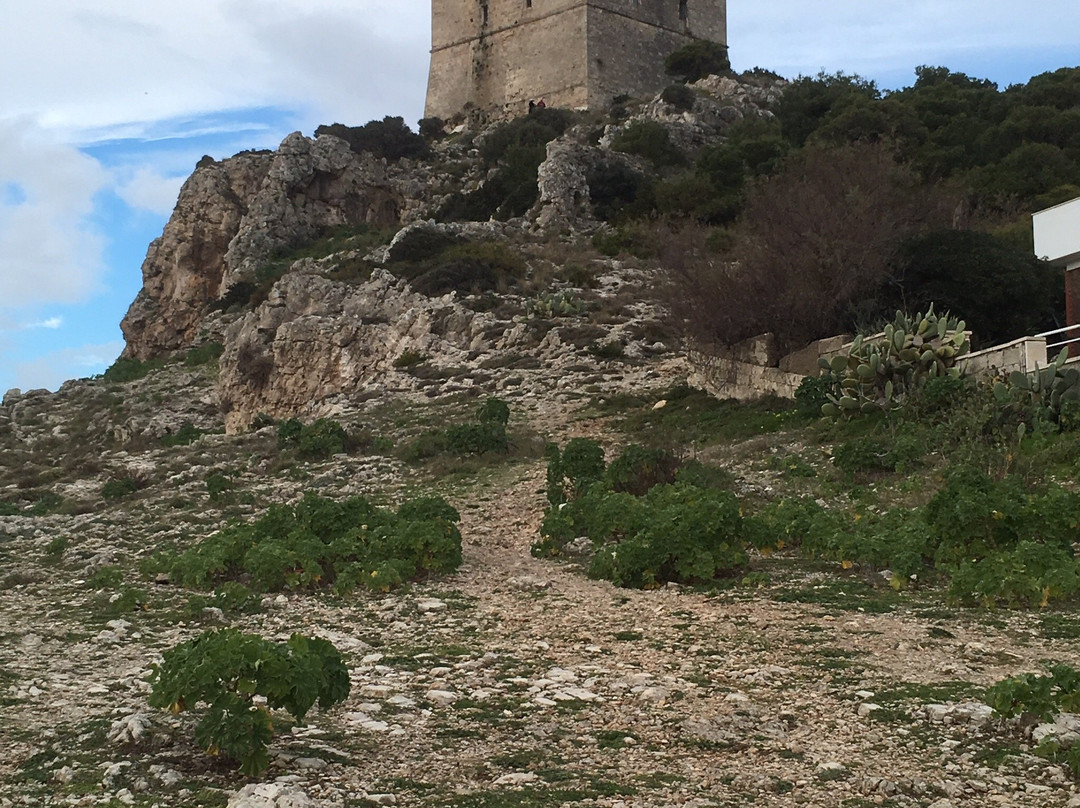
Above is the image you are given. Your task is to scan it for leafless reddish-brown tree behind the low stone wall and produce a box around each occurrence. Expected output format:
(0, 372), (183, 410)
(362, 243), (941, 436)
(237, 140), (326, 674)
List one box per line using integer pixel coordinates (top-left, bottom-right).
(661, 145), (950, 349)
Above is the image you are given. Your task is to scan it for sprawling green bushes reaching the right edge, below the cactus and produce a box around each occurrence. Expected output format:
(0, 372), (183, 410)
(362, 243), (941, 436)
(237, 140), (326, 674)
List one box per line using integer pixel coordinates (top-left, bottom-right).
(755, 467), (1080, 607)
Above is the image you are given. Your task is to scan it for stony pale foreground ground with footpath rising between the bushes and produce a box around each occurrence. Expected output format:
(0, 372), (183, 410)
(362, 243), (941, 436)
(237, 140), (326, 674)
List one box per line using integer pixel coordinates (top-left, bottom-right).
(0, 382), (1080, 808)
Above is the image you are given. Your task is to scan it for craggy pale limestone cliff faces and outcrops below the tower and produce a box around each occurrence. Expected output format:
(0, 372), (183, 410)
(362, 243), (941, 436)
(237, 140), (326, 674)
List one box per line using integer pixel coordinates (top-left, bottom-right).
(122, 77), (779, 432)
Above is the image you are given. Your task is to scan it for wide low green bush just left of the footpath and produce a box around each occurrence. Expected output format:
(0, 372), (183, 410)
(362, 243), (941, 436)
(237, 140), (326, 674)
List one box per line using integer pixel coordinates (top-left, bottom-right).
(170, 494), (461, 592)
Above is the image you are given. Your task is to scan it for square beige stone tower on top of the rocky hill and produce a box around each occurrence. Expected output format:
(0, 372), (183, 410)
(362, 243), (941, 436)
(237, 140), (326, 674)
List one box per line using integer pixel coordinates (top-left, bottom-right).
(424, 0), (727, 120)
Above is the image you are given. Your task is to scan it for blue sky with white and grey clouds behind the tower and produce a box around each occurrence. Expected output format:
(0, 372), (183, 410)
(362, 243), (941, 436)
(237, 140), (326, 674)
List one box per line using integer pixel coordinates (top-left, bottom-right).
(0, 0), (1080, 393)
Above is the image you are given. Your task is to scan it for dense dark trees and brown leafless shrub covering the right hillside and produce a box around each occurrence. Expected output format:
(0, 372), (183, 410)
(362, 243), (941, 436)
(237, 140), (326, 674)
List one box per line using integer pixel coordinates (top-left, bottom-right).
(609, 67), (1080, 348)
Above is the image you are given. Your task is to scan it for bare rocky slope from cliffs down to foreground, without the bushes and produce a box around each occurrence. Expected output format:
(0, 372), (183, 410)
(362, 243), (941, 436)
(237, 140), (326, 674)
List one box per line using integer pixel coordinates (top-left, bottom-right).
(6, 79), (1080, 808)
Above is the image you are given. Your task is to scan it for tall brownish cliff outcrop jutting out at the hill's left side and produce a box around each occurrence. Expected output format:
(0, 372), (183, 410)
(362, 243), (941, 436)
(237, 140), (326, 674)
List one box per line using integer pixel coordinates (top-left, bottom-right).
(121, 133), (407, 359)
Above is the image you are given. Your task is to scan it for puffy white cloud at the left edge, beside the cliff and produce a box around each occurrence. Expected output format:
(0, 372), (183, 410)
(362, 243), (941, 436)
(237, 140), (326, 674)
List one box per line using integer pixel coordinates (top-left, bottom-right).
(0, 119), (108, 308)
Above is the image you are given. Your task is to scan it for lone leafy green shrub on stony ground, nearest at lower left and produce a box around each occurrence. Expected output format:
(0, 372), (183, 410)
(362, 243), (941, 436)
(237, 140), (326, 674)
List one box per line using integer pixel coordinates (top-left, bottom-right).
(149, 629), (350, 777)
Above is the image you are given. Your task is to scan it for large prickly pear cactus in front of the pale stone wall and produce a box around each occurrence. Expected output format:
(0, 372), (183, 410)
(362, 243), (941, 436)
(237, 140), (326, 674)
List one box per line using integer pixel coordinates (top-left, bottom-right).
(819, 304), (971, 418)
